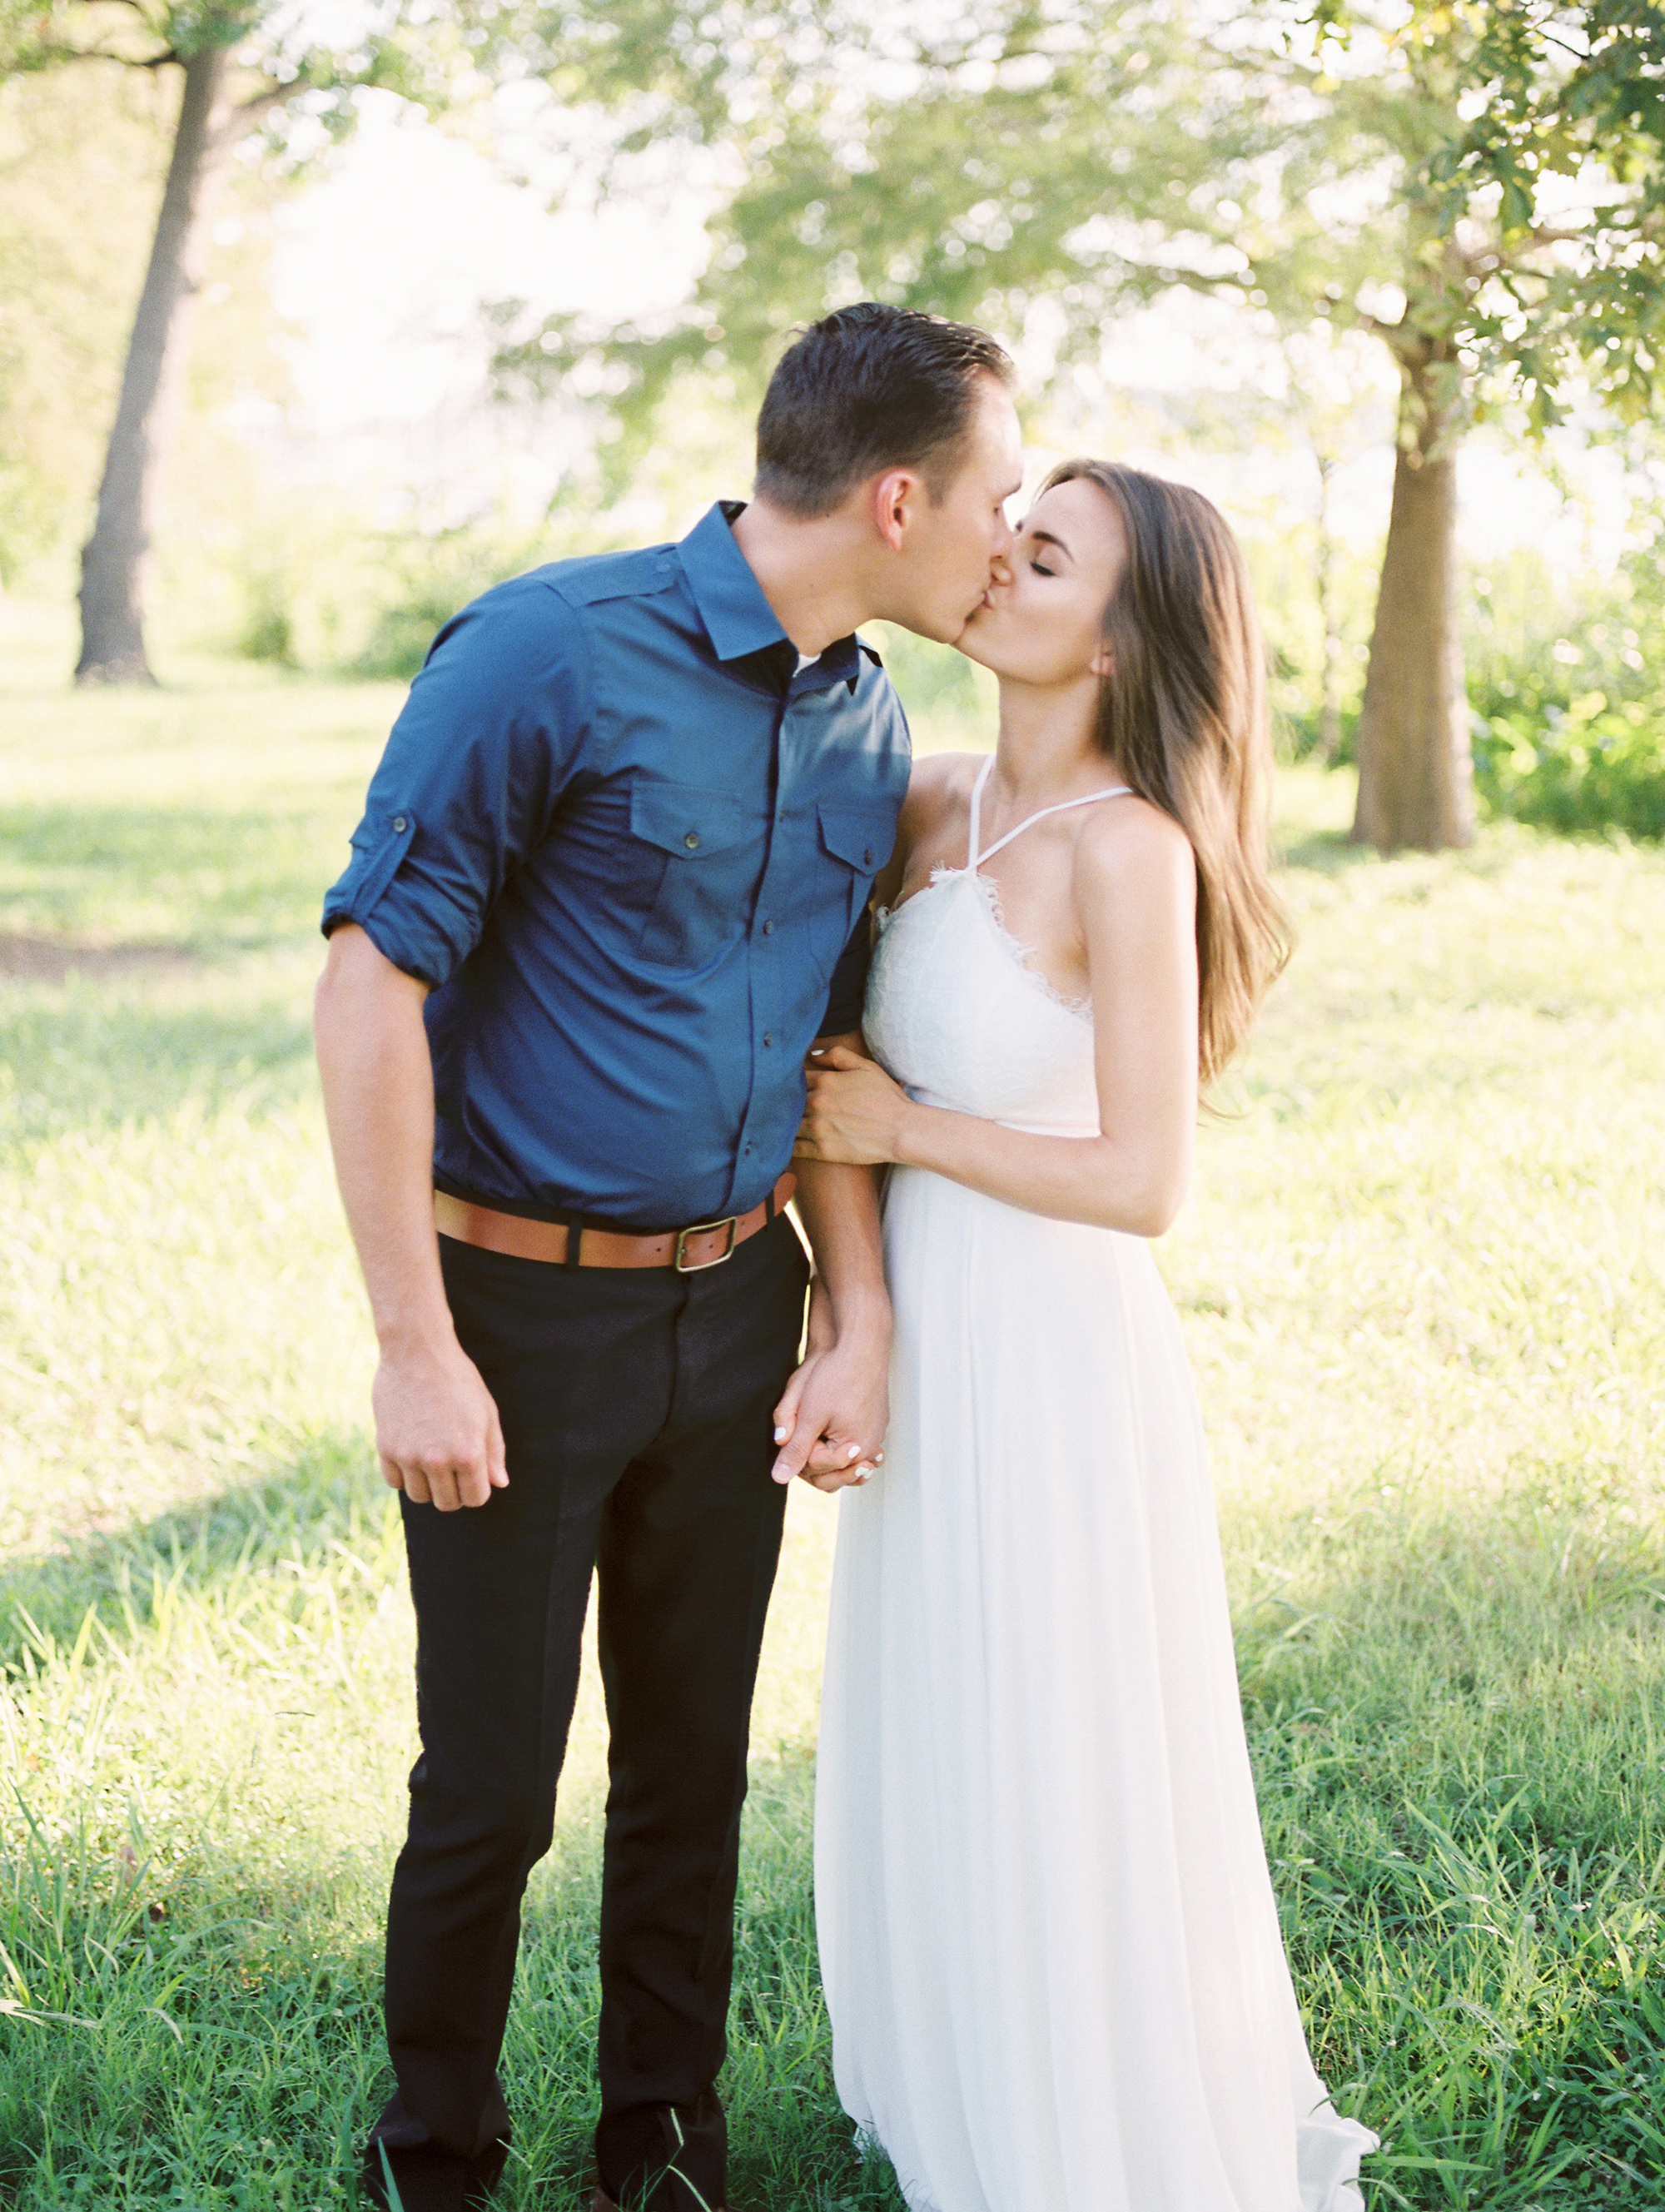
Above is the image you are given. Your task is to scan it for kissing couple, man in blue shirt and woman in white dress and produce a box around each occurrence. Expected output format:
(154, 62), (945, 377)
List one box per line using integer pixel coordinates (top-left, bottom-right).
(316, 303), (1375, 2212)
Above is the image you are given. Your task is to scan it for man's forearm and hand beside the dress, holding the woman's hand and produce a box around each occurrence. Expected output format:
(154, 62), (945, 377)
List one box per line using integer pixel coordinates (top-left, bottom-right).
(774, 1033), (891, 1491)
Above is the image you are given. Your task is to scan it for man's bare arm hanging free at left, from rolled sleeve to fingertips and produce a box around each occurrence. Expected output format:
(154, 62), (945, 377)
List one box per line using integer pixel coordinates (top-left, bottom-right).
(314, 922), (504, 1513)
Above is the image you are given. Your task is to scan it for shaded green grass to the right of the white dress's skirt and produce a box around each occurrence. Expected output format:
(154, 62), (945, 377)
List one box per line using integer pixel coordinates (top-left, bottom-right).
(1238, 1499), (1665, 2212)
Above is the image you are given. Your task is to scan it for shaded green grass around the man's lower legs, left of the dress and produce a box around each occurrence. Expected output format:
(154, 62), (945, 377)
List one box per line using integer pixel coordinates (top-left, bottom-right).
(0, 1765), (902, 2212)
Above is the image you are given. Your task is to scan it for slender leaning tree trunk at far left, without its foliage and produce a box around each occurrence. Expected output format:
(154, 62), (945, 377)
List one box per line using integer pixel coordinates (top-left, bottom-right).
(75, 47), (228, 683)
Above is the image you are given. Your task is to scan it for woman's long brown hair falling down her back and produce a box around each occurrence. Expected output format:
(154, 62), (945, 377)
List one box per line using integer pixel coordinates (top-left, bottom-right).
(1041, 460), (1289, 1084)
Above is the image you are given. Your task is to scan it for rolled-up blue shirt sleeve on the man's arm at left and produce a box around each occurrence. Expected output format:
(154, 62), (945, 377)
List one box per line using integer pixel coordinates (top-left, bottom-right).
(323, 577), (589, 989)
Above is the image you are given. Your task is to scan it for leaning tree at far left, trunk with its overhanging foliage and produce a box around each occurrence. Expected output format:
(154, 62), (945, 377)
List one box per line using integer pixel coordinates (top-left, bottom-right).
(0, 0), (493, 683)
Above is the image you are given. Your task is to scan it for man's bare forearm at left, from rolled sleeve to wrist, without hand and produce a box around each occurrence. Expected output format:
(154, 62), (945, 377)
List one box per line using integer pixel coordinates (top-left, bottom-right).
(314, 925), (453, 1347)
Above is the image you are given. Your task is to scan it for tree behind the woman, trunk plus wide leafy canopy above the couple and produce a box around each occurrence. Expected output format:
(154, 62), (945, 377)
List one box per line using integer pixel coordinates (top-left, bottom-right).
(500, 0), (1665, 848)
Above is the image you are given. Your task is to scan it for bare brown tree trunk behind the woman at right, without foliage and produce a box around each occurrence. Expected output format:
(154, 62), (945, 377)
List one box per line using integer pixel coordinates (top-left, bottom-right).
(1353, 358), (1475, 852)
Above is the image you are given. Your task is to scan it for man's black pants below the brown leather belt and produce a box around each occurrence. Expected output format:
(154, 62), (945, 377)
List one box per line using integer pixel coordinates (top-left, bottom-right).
(367, 1221), (807, 2212)
